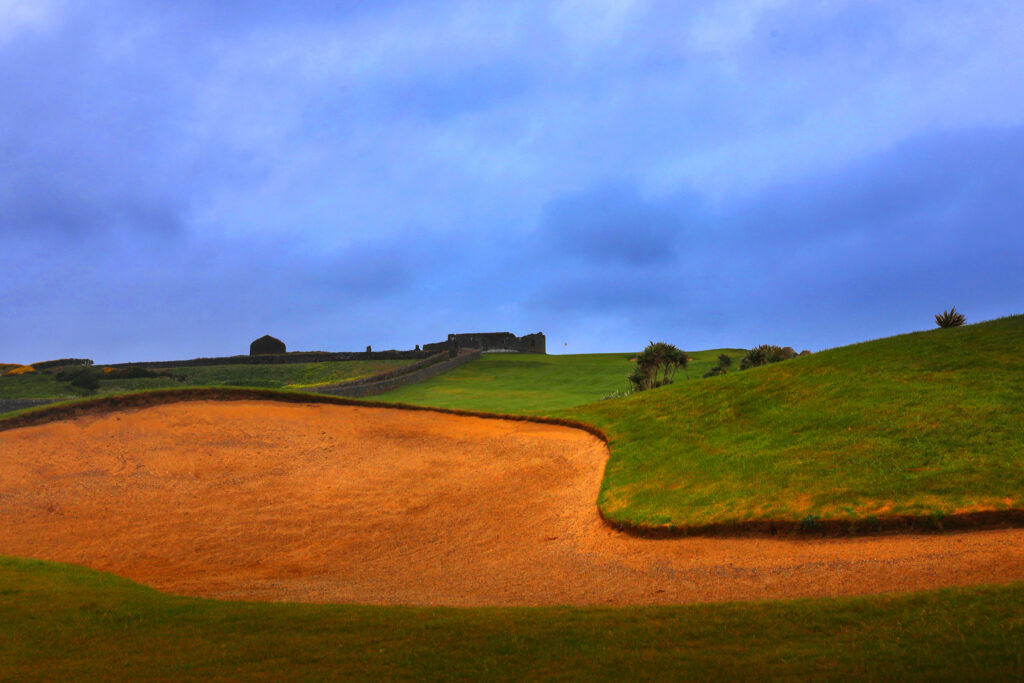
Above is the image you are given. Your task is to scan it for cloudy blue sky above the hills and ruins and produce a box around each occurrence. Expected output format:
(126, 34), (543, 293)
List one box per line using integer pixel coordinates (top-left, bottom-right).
(0, 0), (1024, 364)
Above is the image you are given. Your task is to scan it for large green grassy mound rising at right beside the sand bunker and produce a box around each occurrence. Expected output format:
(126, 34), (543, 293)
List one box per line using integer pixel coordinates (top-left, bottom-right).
(565, 315), (1024, 526)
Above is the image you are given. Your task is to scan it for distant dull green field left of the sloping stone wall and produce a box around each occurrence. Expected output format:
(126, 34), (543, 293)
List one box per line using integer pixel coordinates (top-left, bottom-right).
(0, 360), (414, 398)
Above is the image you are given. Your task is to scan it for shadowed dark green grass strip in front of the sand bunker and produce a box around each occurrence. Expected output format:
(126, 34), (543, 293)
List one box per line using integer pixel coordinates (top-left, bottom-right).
(0, 558), (1024, 680)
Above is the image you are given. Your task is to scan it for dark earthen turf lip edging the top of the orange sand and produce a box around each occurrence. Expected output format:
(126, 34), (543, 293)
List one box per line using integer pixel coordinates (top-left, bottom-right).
(8, 387), (1024, 539)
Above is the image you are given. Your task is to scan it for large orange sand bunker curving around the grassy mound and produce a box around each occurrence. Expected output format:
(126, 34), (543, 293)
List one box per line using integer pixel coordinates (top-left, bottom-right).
(0, 401), (1024, 605)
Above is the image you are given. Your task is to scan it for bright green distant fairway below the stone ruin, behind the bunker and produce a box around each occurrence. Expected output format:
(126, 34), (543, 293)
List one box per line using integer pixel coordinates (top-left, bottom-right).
(374, 349), (742, 415)
